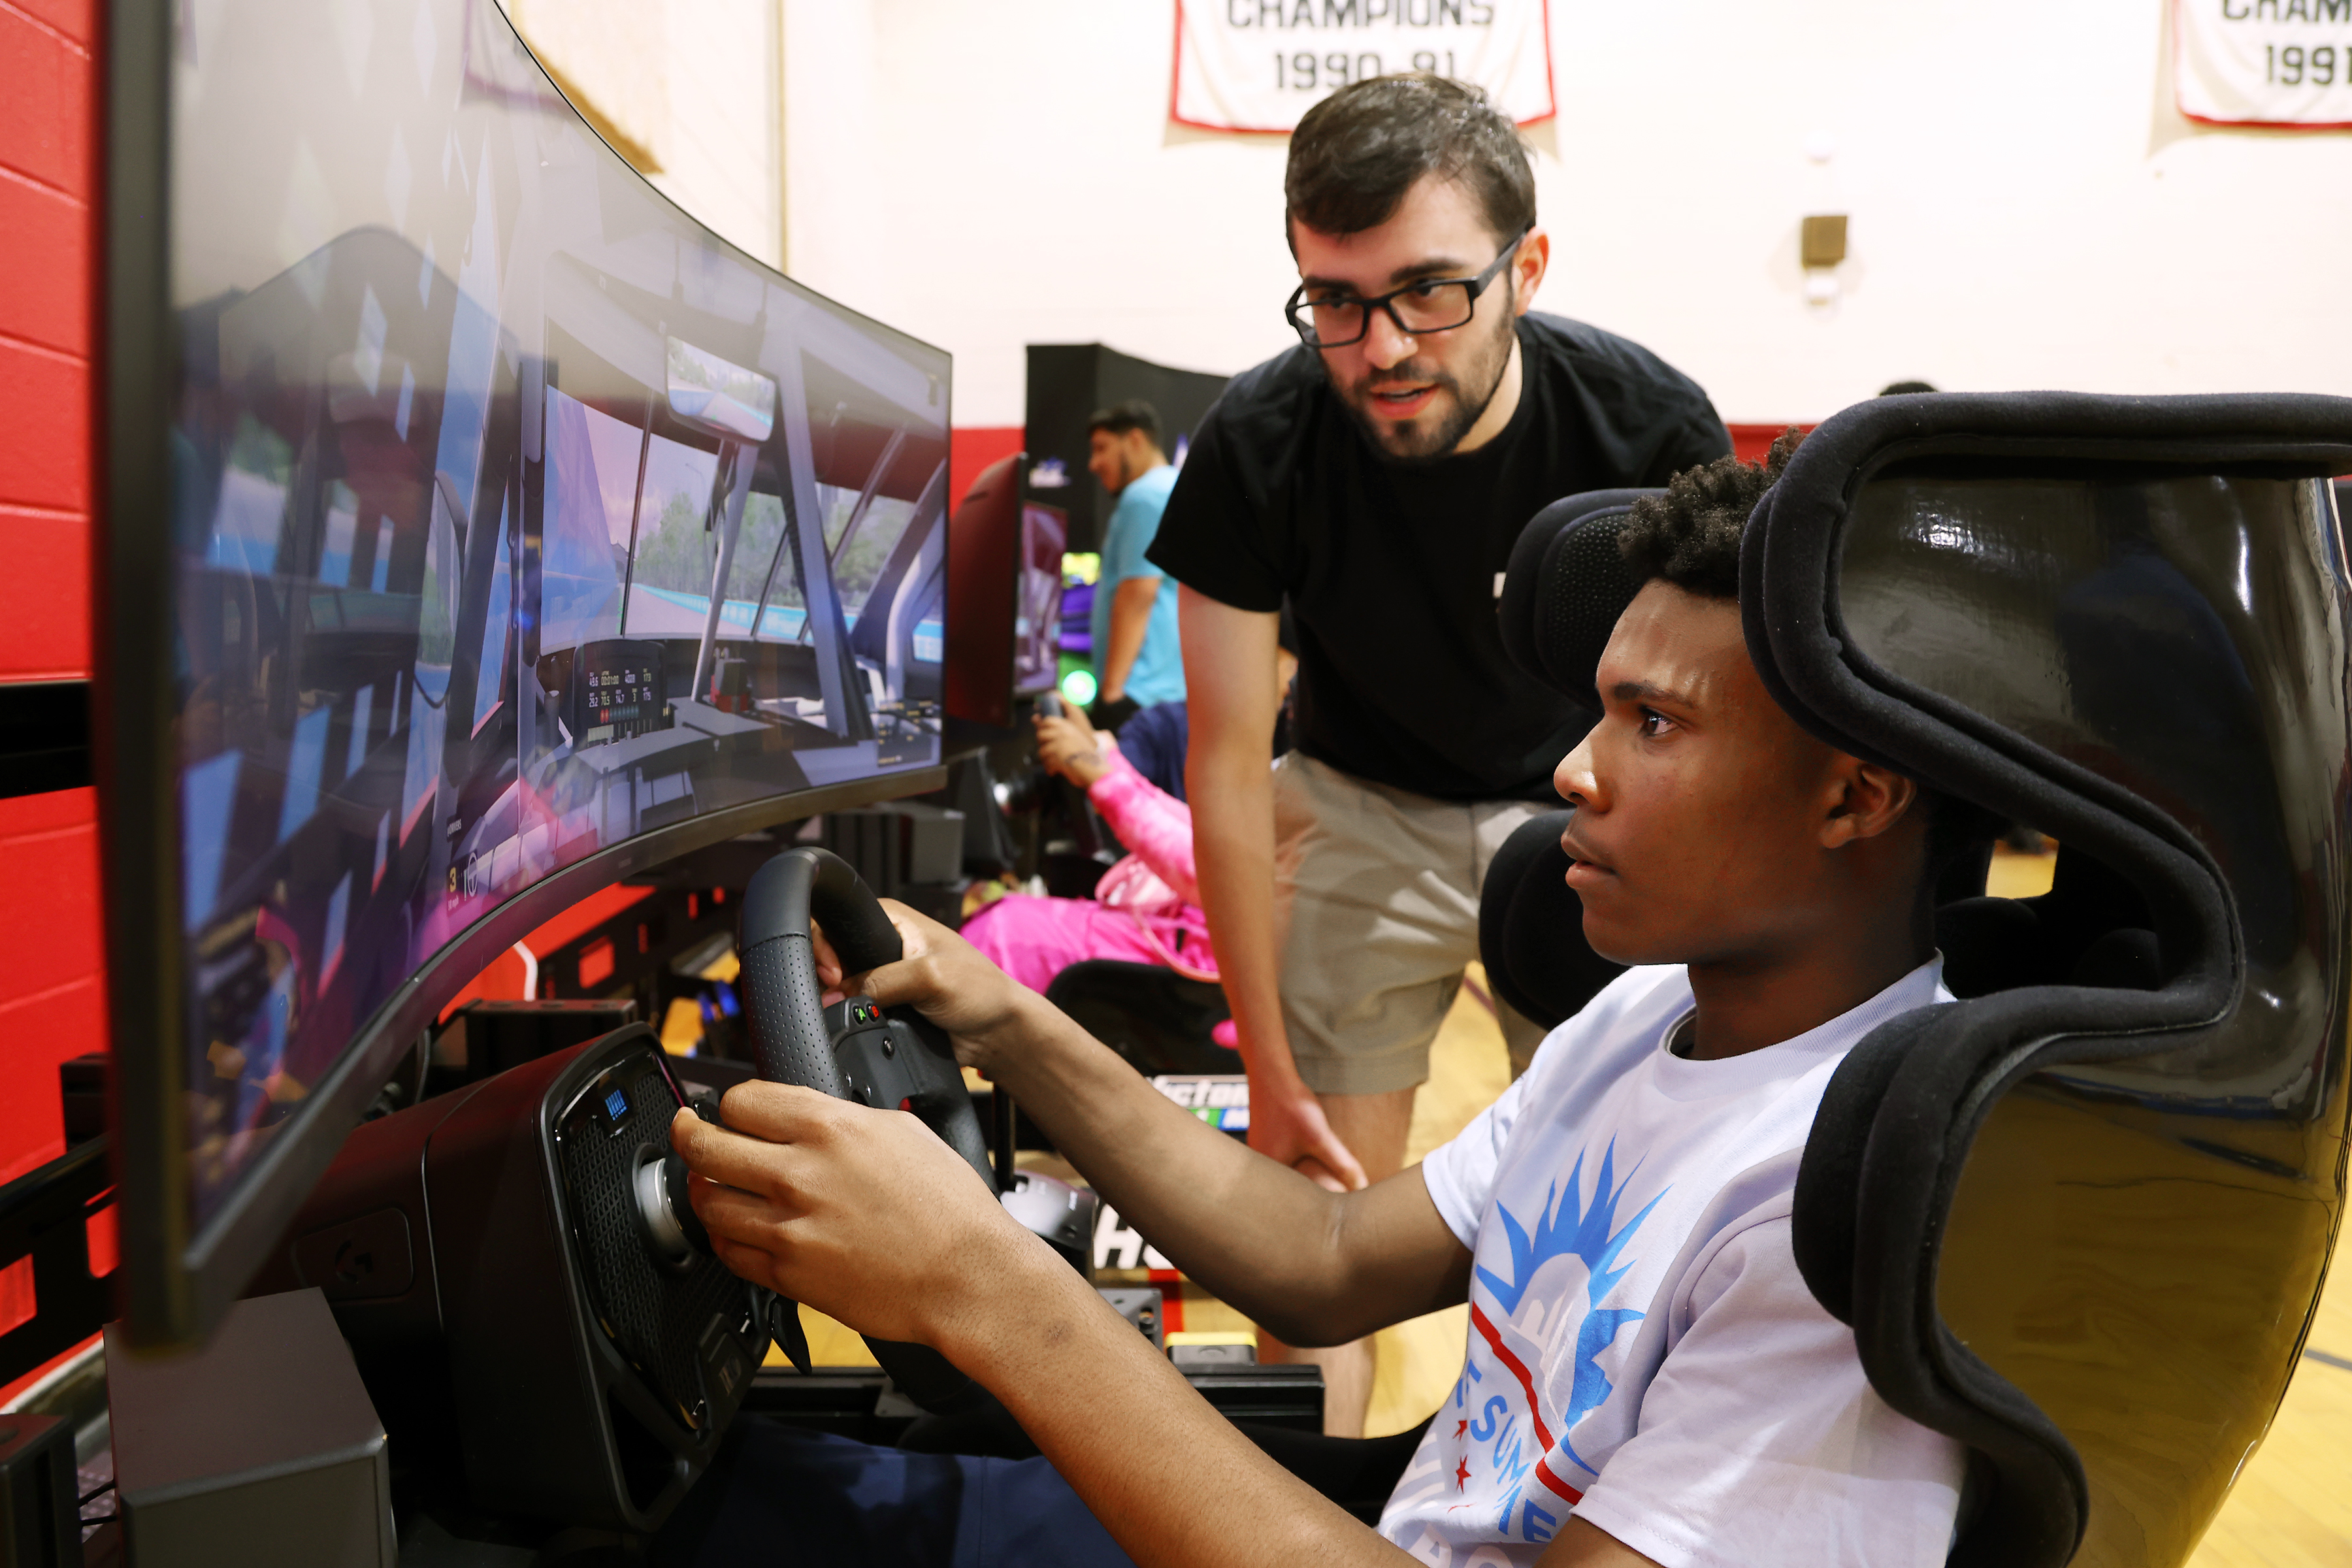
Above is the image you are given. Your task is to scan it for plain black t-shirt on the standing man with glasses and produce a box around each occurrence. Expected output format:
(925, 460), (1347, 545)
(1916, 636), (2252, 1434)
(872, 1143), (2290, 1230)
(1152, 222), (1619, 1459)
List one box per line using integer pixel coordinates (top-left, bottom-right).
(1148, 315), (1731, 799)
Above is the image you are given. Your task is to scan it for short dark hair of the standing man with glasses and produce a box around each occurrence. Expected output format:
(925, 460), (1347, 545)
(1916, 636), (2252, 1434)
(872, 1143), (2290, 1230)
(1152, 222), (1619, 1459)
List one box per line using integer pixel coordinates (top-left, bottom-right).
(1282, 71), (1536, 244)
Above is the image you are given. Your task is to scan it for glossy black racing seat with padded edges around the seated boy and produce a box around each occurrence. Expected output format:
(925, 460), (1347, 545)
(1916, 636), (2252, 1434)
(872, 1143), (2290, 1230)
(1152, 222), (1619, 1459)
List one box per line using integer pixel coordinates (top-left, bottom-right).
(1482, 393), (2352, 1568)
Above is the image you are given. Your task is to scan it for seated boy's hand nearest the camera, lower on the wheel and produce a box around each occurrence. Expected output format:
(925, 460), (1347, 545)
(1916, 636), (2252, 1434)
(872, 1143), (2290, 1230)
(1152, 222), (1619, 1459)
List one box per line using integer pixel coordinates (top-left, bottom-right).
(670, 1084), (1044, 1349)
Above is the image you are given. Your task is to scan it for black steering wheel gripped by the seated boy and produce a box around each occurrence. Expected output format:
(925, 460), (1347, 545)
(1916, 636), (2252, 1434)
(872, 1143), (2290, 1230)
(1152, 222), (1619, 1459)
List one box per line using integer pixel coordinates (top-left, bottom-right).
(738, 849), (997, 1411)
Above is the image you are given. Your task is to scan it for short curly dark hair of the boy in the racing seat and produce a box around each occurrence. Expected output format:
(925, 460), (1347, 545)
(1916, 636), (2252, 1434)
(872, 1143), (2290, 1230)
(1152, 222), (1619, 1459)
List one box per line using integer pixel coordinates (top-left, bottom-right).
(1618, 425), (2002, 883)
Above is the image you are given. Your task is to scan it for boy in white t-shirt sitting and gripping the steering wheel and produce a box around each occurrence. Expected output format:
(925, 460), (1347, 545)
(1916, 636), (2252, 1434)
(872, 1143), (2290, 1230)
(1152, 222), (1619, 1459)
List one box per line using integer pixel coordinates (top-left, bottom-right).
(666, 437), (1990, 1568)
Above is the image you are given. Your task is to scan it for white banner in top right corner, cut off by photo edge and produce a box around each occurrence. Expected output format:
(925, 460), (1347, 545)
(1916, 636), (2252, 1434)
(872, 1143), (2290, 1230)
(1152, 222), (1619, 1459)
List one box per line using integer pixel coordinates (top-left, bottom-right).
(2173, 0), (2352, 129)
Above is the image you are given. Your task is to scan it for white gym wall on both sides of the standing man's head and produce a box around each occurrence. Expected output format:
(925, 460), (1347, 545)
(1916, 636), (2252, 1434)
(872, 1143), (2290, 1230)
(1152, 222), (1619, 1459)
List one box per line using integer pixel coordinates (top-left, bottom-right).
(781, 0), (2352, 425)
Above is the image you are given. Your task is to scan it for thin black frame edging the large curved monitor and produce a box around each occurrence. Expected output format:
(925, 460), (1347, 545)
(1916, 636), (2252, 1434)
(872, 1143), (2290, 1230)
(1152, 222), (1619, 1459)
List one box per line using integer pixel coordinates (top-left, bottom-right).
(90, 0), (955, 1349)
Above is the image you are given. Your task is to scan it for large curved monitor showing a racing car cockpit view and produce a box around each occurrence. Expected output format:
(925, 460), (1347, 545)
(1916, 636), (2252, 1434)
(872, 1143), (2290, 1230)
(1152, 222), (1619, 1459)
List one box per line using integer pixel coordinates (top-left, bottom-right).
(99, 0), (948, 1343)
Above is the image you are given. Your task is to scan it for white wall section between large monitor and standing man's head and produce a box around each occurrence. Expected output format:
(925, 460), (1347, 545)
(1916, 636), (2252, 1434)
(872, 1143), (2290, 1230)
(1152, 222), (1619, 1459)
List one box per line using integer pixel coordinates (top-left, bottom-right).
(783, 0), (1298, 425)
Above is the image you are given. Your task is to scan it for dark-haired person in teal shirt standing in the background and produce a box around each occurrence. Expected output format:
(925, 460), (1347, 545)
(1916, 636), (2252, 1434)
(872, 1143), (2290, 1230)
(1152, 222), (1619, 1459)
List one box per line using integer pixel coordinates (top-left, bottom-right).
(1086, 397), (1183, 727)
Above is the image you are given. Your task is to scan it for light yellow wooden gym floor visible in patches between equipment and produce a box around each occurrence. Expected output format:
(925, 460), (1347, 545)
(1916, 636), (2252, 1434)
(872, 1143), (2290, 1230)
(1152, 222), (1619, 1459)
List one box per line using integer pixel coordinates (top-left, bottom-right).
(794, 851), (2352, 1568)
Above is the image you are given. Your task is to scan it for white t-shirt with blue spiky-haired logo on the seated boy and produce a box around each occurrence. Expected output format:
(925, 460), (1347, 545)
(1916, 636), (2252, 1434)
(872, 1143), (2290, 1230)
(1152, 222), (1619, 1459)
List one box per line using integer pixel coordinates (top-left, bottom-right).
(1380, 959), (1961, 1568)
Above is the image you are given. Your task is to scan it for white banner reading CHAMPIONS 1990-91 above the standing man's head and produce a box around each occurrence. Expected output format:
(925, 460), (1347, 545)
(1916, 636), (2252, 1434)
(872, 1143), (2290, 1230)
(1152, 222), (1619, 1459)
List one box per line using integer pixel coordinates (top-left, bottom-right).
(1169, 0), (1552, 131)
